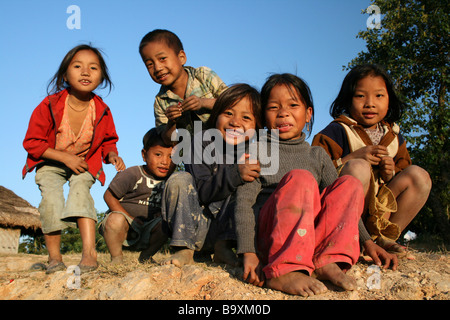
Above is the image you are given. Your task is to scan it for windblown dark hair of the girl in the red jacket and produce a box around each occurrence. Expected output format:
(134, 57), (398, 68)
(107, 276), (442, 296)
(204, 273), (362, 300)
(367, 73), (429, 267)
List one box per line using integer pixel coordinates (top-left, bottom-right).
(47, 44), (113, 95)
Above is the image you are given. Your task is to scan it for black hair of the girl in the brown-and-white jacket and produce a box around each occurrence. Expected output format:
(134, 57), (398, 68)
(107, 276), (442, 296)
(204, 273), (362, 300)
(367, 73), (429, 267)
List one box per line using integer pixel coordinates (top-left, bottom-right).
(330, 64), (404, 123)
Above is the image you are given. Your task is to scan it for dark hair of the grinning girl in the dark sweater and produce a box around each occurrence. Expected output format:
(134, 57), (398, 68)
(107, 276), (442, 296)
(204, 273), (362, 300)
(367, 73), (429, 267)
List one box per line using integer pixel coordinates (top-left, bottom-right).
(207, 83), (262, 130)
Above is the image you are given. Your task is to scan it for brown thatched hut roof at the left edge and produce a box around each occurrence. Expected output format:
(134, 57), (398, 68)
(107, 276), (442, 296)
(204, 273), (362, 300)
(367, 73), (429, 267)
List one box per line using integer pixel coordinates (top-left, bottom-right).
(0, 186), (41, 233)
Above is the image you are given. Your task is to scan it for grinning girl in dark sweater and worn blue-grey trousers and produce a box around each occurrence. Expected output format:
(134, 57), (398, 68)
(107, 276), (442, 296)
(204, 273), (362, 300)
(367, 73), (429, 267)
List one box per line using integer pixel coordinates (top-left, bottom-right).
(162, 84), (261, 267)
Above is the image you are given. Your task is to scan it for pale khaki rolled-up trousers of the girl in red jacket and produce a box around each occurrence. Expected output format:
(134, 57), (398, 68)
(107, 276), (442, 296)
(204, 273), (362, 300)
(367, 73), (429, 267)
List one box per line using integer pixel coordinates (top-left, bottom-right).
(35, 164), (97, 234)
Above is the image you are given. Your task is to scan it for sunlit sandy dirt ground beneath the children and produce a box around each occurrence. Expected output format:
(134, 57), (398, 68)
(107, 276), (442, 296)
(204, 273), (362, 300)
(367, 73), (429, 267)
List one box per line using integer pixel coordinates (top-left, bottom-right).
(0, 245), (450, 301)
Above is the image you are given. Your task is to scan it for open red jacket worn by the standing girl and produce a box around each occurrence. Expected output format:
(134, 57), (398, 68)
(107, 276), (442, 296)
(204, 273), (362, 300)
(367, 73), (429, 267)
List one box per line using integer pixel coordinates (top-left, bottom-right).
(22, 89), (119, 185)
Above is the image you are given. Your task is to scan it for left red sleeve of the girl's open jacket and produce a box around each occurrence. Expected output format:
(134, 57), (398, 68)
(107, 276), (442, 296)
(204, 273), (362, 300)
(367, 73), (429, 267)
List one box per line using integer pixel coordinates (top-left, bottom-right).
(23, 99), (54, 159)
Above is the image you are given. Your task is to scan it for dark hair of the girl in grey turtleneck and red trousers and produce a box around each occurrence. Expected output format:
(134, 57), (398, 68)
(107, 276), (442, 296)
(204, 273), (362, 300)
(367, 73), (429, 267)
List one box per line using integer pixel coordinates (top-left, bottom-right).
(261, 73), (314, 134)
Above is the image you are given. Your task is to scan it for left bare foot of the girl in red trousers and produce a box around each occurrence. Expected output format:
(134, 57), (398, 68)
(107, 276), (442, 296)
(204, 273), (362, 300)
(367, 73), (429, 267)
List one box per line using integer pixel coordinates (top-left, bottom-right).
(266, 271), (328, 297)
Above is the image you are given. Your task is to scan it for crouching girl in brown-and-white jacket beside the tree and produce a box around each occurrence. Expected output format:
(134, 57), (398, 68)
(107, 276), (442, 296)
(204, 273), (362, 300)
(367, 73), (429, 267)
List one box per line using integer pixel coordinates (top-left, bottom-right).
(313, 65), (431, 261)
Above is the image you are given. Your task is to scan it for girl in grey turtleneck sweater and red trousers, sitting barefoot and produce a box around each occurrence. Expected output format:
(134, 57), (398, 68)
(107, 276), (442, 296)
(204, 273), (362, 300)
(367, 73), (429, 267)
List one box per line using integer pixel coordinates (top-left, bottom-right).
(236, 74), (363, 296)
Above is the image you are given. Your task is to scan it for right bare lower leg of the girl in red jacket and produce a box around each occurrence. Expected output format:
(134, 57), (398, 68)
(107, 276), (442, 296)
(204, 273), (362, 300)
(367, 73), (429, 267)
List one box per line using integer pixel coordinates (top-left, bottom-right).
(77, 218), (98, 267)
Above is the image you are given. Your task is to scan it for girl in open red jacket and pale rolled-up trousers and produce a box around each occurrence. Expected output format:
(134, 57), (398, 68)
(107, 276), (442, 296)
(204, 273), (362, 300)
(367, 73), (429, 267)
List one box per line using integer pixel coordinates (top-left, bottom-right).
(23, 45), (125, 273)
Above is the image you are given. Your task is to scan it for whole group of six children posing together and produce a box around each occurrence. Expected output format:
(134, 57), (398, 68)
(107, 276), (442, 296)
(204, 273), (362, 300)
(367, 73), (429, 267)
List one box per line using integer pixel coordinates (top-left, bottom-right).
(23, 29), (431, 296)
